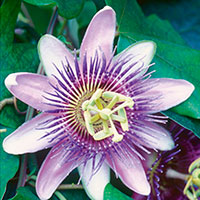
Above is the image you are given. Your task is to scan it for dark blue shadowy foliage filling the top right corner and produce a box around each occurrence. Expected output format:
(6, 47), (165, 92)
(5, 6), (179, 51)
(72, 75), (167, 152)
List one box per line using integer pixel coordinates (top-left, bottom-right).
(141, 0), (200, 49)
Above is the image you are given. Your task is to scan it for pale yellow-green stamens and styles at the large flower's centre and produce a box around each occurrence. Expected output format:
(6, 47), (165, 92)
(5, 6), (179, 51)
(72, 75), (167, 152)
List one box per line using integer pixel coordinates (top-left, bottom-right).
(82, 89), (134, 142)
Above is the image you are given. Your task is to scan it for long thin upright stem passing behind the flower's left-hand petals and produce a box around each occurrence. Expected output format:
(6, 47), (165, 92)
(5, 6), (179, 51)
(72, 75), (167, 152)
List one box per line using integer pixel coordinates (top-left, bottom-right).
(17, 7), (58, 188)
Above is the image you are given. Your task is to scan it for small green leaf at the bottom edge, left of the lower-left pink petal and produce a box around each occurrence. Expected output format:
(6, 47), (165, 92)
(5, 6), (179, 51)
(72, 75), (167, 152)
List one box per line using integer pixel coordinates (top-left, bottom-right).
(11, 187), (39, 200)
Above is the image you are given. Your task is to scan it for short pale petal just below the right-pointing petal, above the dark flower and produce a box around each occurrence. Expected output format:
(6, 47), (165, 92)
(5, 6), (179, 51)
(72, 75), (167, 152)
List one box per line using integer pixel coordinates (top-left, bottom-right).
(132, 122), (174, 151)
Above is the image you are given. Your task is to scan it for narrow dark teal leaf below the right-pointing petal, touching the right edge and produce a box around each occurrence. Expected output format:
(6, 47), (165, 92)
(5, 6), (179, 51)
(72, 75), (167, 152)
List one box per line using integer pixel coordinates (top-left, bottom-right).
(162, 110), (200, 138)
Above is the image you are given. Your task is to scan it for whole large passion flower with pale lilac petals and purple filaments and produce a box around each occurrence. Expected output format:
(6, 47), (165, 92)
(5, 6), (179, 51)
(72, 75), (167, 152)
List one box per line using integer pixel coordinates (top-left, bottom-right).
(3, 6), (194, 199)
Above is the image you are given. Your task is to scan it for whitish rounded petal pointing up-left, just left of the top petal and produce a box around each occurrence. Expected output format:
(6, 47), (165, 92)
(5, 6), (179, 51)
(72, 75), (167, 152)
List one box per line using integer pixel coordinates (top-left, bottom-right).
(38, 34), (74, 76)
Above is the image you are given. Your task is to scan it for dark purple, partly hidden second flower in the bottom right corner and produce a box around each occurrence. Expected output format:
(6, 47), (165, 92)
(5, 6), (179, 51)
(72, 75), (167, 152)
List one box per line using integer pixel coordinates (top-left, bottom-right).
(133, 122), (200, 200)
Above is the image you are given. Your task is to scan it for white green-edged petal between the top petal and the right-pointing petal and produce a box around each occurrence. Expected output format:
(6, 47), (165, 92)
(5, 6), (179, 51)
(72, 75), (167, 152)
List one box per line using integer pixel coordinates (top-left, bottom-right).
(111, 41), (156, 77)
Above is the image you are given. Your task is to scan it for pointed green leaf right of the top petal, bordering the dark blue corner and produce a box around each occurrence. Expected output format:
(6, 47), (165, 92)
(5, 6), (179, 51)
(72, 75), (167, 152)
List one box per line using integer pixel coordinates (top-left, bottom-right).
(106, 0), (185, 44)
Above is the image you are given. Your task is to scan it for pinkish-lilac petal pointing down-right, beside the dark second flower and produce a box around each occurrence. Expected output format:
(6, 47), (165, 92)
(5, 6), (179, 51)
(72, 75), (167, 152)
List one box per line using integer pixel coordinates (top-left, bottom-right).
(107, 155), (151, 195)
